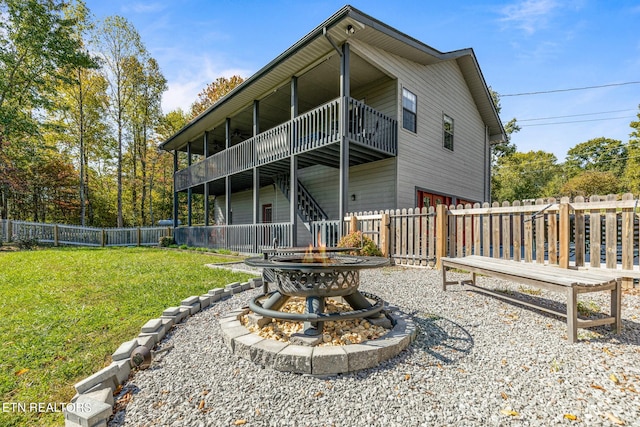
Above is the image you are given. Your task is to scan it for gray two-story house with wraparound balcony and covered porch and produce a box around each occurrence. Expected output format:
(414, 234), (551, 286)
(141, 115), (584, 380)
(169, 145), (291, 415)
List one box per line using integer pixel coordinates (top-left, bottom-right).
(161, 6), (505, 252)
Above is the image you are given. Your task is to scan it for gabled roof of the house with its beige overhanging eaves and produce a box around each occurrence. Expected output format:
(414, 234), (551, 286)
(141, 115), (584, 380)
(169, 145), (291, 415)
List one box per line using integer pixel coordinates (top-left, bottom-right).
(160, 5), (506, 151)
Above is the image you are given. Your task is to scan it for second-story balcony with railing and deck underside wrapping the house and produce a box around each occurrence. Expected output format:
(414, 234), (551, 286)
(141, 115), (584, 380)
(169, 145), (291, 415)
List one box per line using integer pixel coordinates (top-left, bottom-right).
(175, 97), (398, 192)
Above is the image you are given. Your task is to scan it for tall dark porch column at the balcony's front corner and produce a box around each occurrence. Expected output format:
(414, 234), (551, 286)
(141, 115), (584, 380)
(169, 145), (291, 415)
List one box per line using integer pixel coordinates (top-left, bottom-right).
(338, 43), (351, 234)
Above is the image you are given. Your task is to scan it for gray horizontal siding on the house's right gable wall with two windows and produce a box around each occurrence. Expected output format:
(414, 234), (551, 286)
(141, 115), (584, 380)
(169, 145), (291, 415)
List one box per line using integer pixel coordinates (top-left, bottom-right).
(353, 42), (487, 207)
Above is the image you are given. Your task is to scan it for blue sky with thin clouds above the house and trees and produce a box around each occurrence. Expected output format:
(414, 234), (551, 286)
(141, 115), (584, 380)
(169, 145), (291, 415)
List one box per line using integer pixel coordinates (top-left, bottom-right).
(86, 0), (640, 161)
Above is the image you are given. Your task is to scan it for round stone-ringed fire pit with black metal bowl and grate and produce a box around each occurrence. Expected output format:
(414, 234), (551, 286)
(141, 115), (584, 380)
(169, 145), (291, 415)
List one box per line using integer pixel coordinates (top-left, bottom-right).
(221, 248), (416, 375)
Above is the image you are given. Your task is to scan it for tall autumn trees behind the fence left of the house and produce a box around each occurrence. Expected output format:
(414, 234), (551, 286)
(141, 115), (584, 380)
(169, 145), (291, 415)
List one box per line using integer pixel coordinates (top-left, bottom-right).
(0, 0), (242, 227)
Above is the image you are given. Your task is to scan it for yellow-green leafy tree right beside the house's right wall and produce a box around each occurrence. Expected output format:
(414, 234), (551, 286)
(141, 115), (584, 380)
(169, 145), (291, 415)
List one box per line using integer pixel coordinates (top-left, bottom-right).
(493, 151), (559, 201)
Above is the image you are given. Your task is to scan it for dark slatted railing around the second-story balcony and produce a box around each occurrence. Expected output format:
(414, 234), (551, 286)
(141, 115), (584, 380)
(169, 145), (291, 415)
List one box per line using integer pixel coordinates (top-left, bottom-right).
(174, 98), (397, 191)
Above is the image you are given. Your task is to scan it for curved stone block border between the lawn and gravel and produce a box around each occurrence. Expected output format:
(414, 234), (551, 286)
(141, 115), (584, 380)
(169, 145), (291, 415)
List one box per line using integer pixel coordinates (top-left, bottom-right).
(64, 278), (262, 427)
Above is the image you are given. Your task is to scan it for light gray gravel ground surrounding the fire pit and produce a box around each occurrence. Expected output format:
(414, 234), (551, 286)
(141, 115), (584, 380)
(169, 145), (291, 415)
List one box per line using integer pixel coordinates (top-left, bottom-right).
(110, 267), (640, 426)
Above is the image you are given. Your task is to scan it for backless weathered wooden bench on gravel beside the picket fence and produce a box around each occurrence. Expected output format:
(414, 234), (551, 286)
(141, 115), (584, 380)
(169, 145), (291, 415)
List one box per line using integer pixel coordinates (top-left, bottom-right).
(440, 255), (622, 342)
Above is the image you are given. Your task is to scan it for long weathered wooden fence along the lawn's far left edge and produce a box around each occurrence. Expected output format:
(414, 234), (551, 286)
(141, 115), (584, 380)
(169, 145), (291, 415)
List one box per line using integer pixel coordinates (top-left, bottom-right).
(0, 219), (172, 246)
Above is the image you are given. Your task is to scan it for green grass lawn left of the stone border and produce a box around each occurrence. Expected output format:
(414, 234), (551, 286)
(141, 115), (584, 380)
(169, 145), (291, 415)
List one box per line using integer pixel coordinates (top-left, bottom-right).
(0, 248), (251, 426)
